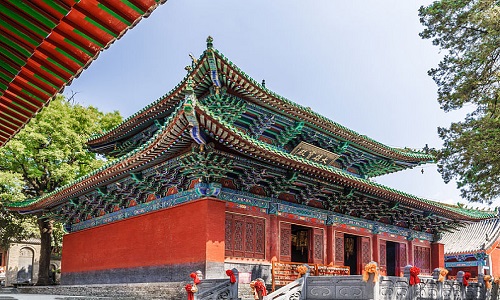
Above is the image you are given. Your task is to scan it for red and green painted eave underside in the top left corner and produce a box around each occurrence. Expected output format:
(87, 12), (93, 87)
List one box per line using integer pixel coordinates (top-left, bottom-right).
(0, 0), (166, 146)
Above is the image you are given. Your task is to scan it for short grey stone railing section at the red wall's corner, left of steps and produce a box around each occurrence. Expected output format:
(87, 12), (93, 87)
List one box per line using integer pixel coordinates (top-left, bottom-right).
(194, 269), (238, 300)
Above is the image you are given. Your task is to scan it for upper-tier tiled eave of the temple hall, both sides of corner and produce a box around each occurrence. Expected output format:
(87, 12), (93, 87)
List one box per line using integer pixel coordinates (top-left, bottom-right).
(88, 48), (434, 164)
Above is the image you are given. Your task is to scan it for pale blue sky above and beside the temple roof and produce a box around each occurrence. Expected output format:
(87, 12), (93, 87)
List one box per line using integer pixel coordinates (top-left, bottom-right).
(64, 0), (478, 209)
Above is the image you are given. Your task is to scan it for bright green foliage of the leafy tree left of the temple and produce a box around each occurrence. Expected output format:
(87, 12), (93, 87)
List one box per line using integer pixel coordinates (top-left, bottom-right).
(0, 95), (122, 278)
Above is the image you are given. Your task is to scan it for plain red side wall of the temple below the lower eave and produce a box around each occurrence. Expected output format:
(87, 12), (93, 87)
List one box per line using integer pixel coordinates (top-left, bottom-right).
(62, 199), (225, 272)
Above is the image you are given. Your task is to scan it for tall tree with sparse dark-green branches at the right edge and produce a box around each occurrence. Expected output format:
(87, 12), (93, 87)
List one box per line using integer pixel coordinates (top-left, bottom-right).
(419, 0), (500, 204)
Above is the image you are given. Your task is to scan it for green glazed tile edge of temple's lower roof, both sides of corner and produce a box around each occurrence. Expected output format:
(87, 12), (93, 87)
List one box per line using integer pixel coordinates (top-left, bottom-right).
(10, 86), (495, 220)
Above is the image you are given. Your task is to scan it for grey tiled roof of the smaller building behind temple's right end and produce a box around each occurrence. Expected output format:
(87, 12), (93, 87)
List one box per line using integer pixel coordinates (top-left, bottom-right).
(439, 218), (500, 255)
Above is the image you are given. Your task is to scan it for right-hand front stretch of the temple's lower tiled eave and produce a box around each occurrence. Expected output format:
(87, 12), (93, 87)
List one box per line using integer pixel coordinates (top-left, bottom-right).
(196, 104), (494, 221)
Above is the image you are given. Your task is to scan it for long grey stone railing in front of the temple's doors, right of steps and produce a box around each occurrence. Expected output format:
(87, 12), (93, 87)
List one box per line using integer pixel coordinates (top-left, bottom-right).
(263, 266), (500, 300)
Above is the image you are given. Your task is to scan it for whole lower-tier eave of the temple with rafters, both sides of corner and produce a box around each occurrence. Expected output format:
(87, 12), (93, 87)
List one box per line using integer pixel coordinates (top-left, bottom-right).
(9, 94), (495, 220)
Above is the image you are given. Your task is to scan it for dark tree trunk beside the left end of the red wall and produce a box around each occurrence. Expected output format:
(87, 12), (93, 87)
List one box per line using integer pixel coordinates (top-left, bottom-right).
(36, 216), (52, 285)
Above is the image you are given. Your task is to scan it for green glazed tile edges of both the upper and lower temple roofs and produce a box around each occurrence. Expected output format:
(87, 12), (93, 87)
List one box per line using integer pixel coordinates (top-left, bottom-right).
(11, 40), (495, 220)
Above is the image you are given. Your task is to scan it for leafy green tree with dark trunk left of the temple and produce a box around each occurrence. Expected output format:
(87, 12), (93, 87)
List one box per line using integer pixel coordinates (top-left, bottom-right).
(0, 95), (122, 285)
